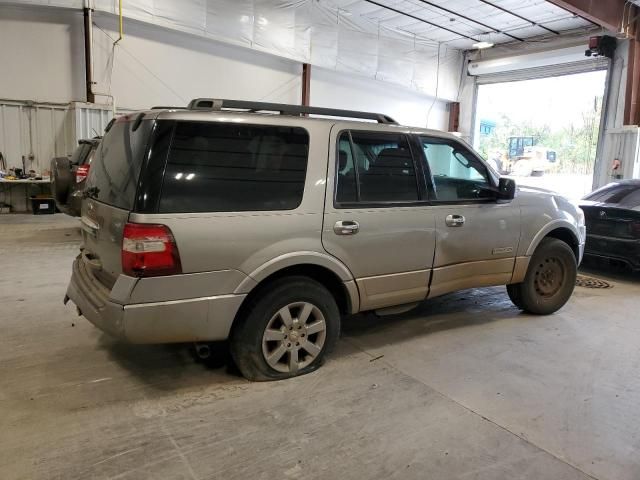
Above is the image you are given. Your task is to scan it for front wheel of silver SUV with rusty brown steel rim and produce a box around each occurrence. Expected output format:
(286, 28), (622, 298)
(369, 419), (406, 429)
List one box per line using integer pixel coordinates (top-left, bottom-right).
(507, 238), (578, 315)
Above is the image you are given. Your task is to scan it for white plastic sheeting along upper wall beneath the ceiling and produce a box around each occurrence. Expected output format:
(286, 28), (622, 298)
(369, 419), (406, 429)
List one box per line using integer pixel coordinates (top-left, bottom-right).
(0, 0), (462, 100)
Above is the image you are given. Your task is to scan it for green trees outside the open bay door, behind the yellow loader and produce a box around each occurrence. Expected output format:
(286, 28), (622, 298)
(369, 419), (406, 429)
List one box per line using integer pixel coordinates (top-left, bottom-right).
(478, 97), (602, 174)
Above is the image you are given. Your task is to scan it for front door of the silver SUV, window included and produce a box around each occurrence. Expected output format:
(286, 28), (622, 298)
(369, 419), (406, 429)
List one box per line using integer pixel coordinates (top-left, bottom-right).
(420, 136), (520, 297)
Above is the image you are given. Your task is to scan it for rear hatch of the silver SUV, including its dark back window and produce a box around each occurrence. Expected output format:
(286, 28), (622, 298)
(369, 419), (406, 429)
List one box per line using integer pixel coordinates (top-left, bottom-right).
(80, 114), (153, 289)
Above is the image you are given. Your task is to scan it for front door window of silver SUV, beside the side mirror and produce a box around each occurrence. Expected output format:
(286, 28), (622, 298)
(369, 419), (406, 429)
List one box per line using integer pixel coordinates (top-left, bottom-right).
(421, 137), (493, 202)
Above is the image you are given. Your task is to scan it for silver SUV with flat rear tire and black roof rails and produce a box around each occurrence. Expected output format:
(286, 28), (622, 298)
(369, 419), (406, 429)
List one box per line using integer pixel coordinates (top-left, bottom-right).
(65, 99), (585, 380)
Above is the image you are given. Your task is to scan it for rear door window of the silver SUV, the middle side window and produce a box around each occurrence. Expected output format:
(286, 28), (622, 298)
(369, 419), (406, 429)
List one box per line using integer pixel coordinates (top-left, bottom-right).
(336, 131), (419, 203)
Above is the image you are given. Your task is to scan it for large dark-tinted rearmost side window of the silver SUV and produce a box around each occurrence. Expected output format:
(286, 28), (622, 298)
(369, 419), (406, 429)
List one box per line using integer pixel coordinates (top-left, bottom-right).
(159, 122), (309, 213)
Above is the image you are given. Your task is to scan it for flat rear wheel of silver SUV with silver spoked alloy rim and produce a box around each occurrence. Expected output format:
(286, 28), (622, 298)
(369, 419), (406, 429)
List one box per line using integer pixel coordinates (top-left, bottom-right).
(230, 276), (340, 381)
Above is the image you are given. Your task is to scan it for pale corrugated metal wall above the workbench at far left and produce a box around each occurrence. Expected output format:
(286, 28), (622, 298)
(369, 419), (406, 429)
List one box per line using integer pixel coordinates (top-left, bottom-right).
(0, 100), (125, 211)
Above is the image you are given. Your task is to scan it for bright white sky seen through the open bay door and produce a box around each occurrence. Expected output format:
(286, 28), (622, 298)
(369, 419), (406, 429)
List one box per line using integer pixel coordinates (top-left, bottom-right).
(477, 70), (606, 130)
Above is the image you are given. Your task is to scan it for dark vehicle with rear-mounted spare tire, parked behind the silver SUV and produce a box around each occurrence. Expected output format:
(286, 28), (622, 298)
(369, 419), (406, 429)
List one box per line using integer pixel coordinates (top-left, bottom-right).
(51, 137), (101, 217)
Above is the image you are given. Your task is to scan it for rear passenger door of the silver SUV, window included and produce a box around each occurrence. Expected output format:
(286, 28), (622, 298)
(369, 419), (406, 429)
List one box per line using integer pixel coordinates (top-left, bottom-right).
(322, 124), (435, 310)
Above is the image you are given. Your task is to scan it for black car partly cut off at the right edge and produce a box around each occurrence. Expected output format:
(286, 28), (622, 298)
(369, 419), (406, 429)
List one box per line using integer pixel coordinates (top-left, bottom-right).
(580, 180), (640, 271)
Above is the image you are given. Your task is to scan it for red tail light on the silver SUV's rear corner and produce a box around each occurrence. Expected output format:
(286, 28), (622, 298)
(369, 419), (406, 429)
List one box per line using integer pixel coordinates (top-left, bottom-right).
(122, 223), (182, 277)
